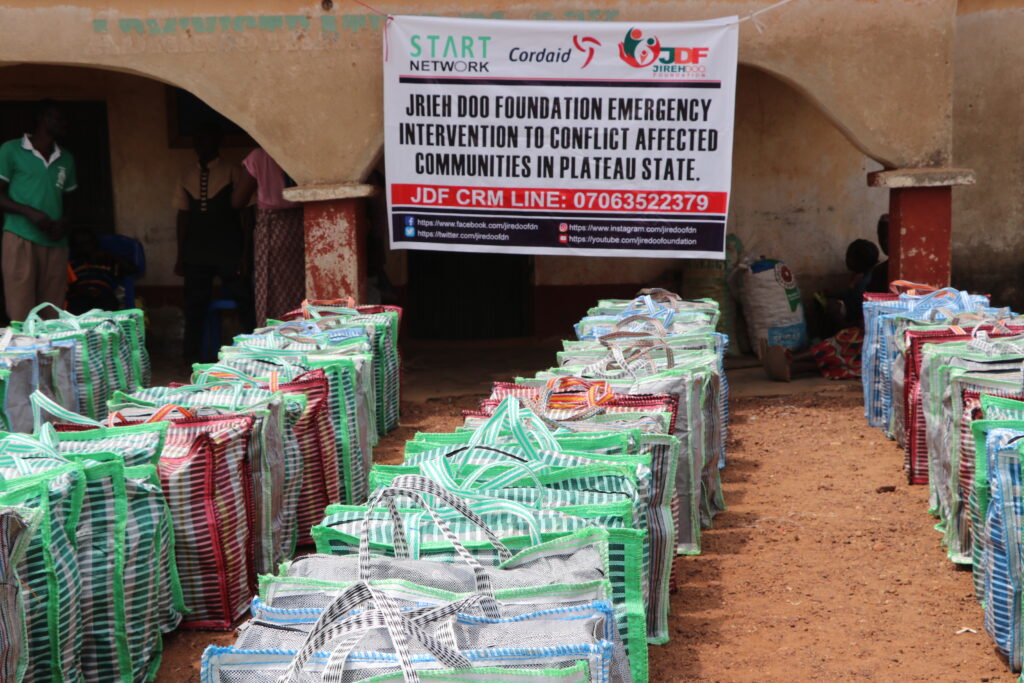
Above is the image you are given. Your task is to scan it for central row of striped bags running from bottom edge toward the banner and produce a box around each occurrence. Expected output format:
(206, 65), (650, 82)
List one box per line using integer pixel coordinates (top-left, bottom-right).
(202, 291), (727, 683)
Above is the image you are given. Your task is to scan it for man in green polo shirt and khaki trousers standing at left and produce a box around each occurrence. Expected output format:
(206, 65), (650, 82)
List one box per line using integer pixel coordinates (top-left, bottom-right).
(0, 100), (78, 321)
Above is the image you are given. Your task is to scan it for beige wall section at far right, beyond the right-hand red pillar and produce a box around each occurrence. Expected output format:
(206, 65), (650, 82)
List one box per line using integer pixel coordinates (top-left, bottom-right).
(953, 0), (1024, 310)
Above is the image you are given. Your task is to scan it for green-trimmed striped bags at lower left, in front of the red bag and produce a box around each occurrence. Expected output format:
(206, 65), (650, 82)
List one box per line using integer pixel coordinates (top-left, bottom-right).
(0, 423), (184, 681)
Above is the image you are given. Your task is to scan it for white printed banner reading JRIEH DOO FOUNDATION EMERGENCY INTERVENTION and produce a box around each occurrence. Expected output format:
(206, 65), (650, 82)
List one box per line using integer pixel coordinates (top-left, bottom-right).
(384, 16), (738, 259)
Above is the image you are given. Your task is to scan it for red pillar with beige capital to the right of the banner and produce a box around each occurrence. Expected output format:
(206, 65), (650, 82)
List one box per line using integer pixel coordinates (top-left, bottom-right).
(867, 168), (974, 287)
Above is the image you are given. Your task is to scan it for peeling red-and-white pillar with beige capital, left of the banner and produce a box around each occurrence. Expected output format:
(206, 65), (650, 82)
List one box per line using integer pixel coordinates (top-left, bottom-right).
(285, 183), (375, 302)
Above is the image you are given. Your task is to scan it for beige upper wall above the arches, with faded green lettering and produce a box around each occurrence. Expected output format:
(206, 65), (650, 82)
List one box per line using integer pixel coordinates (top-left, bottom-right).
(0, 0), (956, 182)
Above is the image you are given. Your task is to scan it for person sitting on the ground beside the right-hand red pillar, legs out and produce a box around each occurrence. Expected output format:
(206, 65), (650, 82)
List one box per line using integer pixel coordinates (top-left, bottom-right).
(761, 240), (879, 382)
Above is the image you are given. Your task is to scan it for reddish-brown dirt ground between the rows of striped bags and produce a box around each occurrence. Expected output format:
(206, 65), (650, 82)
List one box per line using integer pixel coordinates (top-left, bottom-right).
(158, 384), (1015, 683)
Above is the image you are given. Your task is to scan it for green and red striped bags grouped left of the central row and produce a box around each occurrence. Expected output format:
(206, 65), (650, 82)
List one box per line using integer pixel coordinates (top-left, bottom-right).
(0, 302), (400, 681)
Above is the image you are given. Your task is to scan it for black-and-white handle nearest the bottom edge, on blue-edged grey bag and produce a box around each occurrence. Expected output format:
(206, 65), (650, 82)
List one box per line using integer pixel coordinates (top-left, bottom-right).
(279, 581), (469, 683)
